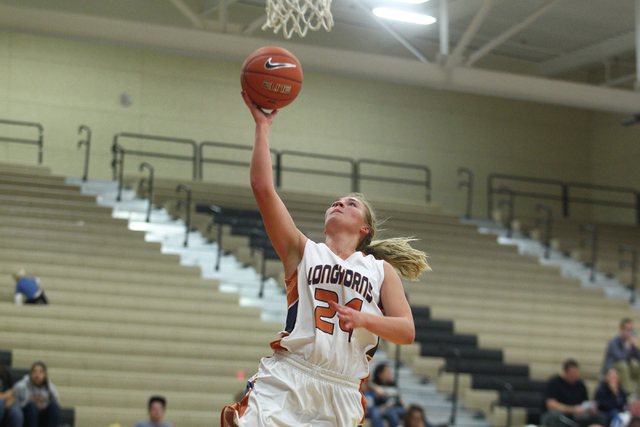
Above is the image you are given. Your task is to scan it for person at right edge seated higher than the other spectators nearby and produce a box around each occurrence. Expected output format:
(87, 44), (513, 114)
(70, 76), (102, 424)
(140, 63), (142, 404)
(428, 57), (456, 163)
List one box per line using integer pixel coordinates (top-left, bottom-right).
(602, 318), (640, 395)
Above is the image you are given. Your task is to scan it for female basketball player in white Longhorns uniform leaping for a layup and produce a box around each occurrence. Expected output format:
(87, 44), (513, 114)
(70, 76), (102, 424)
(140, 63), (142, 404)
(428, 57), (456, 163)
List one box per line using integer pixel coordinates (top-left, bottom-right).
(221, 92), (429, 427)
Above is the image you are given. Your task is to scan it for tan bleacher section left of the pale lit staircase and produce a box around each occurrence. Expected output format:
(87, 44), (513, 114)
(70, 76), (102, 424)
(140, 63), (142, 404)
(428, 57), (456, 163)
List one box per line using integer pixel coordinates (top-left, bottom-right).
(0, 165), (281, 427)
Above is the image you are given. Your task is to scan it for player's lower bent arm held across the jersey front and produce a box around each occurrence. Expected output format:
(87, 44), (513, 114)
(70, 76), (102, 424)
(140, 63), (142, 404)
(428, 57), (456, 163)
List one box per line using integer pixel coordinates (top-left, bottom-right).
(329, 261), (416, 344)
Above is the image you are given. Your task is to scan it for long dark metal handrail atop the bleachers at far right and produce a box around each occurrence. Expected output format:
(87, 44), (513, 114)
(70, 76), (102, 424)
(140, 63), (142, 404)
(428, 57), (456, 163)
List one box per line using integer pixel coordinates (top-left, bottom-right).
(487, 173), (640, 224)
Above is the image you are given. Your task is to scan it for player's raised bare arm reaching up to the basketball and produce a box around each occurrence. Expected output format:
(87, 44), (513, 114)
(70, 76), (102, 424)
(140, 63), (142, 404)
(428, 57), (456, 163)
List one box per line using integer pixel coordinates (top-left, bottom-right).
(242, 92), (307, 277)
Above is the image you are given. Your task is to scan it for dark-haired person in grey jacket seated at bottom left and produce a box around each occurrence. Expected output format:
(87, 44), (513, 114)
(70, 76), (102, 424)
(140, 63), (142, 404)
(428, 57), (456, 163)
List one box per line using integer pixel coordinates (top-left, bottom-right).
(13, 362), (61, 427)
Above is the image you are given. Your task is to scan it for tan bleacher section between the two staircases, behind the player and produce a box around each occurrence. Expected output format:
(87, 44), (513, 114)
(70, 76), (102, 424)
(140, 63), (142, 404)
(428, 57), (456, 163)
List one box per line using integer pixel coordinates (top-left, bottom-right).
(128, 178), (639, 426)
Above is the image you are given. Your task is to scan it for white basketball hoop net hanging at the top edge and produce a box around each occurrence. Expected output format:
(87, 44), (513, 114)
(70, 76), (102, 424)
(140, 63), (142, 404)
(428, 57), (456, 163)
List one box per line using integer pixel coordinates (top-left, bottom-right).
(262, 0), (333, 39)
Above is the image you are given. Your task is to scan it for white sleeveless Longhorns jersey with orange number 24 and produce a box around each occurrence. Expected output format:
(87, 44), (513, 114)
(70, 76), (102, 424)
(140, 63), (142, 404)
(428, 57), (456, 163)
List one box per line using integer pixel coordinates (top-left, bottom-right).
(272, 240), (384, 379)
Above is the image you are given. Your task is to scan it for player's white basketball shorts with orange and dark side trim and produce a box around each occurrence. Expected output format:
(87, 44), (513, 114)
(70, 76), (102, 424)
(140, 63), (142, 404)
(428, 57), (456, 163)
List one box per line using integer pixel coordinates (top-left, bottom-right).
(221, 350), (366, 427)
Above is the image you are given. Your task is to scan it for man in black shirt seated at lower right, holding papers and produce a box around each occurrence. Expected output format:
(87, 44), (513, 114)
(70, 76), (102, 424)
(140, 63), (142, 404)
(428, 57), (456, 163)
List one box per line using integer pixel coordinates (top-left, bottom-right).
(541, 359), (606, 427)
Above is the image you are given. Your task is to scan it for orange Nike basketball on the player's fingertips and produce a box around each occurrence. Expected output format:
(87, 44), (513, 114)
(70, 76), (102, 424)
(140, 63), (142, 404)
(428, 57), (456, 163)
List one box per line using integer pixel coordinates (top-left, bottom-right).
(240, 46), (302, 110)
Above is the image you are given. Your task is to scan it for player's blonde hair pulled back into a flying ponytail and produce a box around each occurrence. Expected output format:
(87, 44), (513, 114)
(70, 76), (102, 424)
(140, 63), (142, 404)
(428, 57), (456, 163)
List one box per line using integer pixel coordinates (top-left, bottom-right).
(347, 193), (431, 280)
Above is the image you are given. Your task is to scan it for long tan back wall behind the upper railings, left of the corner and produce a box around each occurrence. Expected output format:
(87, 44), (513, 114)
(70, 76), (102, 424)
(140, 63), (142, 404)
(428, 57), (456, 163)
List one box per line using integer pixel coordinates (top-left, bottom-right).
(0, 32), (591, 215)
